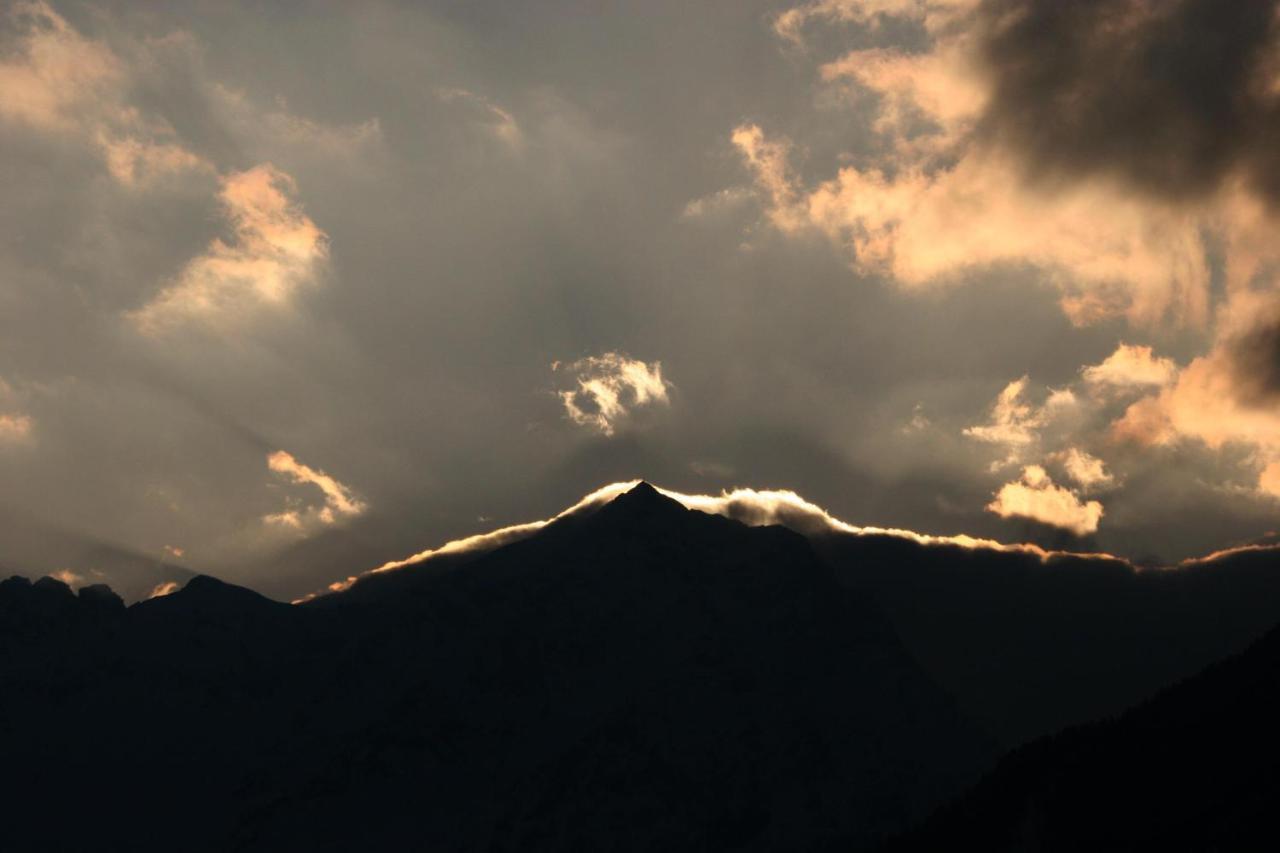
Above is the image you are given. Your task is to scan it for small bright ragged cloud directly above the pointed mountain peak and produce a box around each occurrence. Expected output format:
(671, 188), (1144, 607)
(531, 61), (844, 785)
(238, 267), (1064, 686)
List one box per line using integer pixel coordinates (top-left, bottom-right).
(552, 352), (669, 435)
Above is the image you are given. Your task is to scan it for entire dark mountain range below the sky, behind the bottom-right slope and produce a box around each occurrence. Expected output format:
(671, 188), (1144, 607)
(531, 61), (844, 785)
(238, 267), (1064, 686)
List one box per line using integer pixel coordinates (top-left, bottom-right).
(0, 483), (1280, 850)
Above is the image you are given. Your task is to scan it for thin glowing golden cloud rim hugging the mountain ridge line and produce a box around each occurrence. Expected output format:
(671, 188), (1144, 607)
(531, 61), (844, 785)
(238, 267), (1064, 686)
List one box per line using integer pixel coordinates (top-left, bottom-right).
(293, 480), (1280, 605)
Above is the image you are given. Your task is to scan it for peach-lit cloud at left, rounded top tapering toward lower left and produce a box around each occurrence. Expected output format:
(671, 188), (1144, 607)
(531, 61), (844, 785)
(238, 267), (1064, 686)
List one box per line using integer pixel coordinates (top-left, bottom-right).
(131, 164), (329, 333)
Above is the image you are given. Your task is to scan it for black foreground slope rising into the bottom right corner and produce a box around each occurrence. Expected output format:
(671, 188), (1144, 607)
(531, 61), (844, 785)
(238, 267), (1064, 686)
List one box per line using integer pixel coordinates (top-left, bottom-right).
(890, 614), (1280, 853)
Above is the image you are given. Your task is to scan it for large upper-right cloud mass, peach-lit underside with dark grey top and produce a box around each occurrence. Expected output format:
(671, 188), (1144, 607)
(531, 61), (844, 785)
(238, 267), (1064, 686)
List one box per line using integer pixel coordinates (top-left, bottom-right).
(733, 0), (1280, 328)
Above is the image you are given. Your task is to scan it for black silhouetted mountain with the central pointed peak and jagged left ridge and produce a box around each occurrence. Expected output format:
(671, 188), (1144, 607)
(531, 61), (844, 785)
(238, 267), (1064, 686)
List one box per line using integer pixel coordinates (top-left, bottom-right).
(0, 485), (991, 850)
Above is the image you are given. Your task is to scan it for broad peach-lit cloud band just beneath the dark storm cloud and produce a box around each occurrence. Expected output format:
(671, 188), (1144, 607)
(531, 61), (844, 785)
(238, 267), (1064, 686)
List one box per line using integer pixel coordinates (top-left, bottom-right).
(735, 121), (1210, 327)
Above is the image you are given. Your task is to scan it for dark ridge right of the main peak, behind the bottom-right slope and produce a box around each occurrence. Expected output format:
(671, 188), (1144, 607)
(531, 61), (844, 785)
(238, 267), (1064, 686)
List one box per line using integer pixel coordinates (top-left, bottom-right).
(812, 534), (1280, 747)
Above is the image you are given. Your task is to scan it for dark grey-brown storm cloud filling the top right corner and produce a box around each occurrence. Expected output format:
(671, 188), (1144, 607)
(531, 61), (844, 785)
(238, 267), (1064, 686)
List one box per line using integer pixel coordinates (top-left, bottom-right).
(978, 0), (1280, 204)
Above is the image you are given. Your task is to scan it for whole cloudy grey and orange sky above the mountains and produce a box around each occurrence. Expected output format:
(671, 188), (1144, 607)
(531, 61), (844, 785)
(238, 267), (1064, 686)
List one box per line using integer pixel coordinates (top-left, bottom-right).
(0, 0), (1280, 598)
